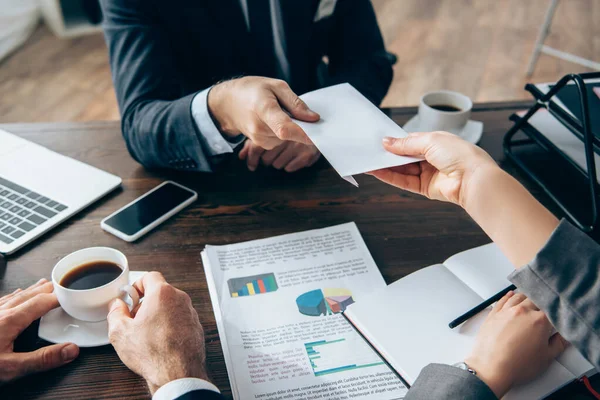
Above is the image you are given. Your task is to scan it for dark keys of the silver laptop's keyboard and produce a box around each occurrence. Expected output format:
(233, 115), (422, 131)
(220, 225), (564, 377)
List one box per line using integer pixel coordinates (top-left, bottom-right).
(0, 177), (68, 244)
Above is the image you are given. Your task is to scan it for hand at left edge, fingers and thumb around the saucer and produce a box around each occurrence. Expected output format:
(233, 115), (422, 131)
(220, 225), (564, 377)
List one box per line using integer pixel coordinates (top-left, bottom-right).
(0, 279), (79, 384)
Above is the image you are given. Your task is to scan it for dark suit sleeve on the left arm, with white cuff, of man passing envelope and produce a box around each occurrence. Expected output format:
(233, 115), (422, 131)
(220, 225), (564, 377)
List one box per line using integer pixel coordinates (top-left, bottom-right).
(101, 0), (218, 171)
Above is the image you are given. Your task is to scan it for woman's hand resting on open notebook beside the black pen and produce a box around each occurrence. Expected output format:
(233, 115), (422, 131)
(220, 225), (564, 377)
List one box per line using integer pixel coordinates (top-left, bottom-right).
(465, 292), (568, 398)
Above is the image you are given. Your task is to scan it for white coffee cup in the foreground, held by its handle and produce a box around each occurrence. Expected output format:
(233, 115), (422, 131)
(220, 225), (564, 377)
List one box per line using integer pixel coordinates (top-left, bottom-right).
(52, 247), (140, 322)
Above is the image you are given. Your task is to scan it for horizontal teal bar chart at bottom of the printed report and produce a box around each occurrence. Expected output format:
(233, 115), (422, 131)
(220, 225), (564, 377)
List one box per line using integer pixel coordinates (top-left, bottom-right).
(304, 337), (384, 376)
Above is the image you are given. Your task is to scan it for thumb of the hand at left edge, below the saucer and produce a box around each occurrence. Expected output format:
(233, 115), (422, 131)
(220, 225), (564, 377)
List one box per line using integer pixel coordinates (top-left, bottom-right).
(13, 343), (79, 379)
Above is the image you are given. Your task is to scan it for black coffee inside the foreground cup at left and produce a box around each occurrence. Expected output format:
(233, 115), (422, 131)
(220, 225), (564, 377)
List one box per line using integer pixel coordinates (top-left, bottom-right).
(59, 261), (123, 290)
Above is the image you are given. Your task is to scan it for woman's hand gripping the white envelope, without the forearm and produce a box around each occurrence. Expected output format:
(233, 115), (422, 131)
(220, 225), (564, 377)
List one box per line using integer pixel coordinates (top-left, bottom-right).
(370, 132), (498, 206)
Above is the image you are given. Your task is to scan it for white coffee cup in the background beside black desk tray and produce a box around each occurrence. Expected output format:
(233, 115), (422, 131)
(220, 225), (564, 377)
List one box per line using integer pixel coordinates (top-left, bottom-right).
(419, 90), (473, 135)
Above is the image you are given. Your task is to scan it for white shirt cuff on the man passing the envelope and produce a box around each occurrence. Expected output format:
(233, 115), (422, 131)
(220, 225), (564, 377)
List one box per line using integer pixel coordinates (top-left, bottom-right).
(192, 87), (245, 156)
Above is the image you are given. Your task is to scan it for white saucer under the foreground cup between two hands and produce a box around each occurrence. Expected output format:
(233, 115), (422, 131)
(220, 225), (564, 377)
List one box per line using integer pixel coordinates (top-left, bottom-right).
(38, 271), (146, 347)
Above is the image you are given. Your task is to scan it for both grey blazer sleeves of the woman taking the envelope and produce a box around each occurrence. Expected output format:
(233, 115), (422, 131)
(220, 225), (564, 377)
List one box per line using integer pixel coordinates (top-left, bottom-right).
(406, 220), (600, 400)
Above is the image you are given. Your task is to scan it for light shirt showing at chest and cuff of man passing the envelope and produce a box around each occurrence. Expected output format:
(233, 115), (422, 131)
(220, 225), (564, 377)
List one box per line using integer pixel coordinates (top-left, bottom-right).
(192, 0), (290, 162)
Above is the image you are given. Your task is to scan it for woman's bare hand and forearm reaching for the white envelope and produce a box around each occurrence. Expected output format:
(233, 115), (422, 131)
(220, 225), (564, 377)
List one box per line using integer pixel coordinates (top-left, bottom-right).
(370, 132), (558, 268)
